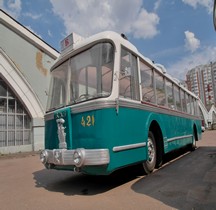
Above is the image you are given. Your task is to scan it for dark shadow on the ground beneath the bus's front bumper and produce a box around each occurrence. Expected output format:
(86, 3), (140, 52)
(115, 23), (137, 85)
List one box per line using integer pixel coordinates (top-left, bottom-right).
(33, 166), (143, 195)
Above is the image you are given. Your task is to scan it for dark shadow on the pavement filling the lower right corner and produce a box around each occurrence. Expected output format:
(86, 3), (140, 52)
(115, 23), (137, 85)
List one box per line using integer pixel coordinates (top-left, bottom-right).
(131, 147), (216, 210)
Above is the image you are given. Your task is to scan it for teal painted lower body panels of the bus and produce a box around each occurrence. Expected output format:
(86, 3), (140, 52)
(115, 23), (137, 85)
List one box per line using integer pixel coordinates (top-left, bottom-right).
(45, 104), (201, 175)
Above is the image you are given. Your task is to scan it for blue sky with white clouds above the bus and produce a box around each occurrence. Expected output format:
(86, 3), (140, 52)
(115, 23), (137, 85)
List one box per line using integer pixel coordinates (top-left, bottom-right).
(0, 0), (216, 80)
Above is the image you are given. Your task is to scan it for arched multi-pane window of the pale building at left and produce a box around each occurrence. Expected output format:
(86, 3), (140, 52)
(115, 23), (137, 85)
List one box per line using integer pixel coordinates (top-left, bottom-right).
(0, 78), (31, 147)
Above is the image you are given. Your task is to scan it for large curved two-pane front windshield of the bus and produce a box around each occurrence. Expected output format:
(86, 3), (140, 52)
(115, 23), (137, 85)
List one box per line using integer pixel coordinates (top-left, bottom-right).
(47, 42), (114, 111)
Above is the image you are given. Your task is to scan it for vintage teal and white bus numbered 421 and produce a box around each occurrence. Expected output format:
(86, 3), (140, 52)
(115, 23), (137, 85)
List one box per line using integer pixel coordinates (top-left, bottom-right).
(40, 31), (201, 175)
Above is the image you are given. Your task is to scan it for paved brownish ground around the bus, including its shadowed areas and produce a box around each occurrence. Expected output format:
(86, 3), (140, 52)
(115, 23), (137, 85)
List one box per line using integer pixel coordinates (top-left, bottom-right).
(0, 131), (216, 210)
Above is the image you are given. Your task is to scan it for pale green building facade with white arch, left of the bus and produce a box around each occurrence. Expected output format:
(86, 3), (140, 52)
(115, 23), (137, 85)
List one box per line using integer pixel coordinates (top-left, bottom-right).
(0, 10), (59, 154)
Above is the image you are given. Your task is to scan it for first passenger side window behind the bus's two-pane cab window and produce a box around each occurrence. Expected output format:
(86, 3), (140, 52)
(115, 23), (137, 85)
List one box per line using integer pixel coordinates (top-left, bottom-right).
(140, 61), (155, 103)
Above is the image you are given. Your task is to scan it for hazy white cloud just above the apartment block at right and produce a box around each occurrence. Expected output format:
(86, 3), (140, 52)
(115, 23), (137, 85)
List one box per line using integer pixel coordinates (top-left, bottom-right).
(167, 47), (216, 79)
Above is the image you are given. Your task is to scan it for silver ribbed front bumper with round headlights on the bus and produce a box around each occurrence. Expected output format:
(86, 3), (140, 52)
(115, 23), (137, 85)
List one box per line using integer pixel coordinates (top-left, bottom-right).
(40, 148), (110, 168)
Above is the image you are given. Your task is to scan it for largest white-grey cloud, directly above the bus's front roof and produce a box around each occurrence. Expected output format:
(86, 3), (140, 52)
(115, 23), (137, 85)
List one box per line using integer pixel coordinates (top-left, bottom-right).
(50, 0), (159, 38)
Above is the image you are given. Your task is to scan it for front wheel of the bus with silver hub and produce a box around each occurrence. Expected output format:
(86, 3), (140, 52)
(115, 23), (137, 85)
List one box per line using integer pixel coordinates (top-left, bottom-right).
(143, 131), (157, 174)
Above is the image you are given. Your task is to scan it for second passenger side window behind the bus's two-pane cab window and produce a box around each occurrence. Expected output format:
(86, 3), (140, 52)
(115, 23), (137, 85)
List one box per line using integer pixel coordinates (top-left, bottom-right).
(154, 72), (166, 106)
